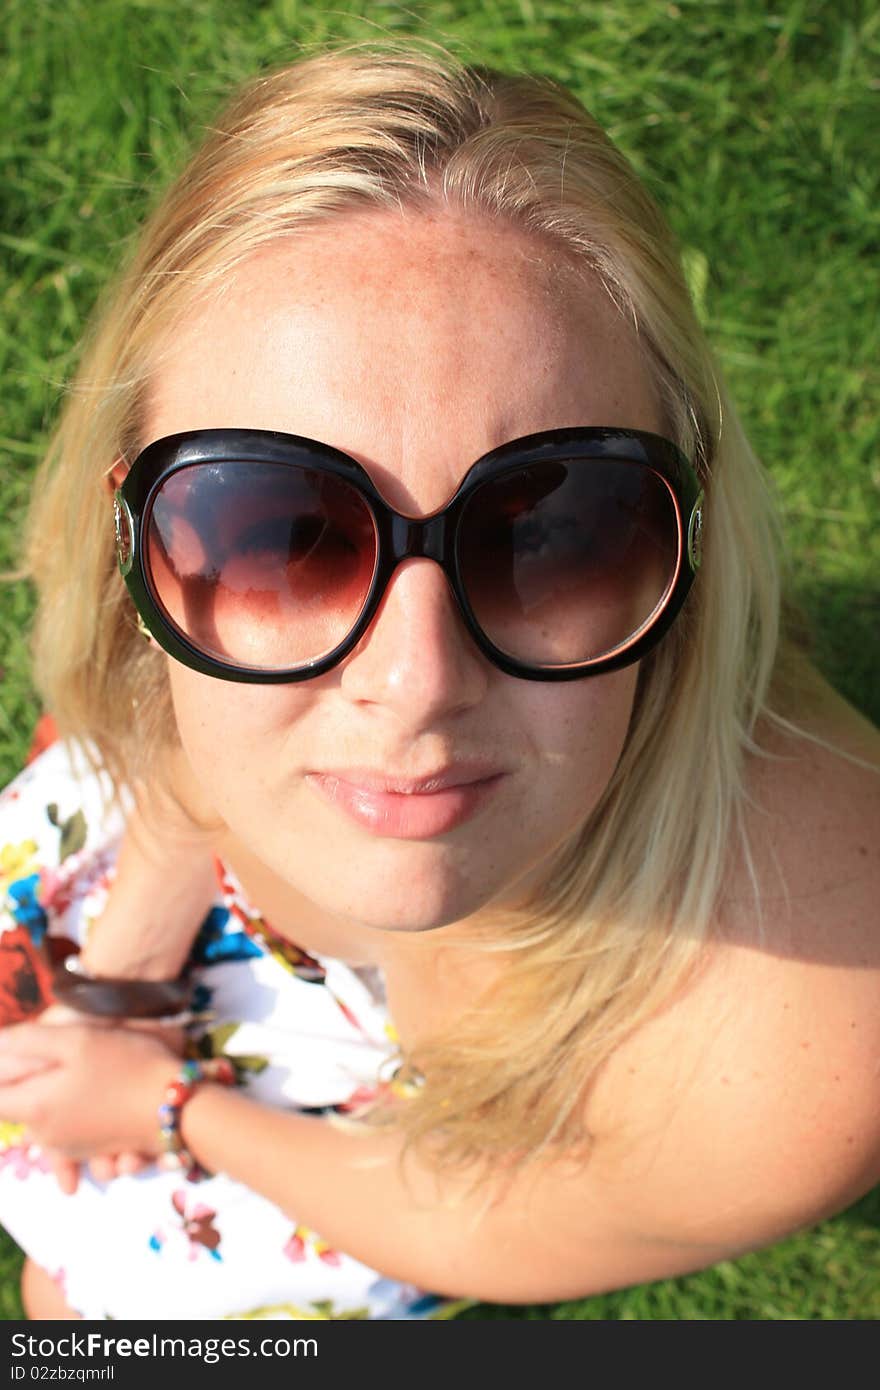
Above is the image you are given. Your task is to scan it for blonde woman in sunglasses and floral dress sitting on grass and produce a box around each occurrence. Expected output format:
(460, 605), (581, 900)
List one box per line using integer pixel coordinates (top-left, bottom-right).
(0, 51), (880, 1318)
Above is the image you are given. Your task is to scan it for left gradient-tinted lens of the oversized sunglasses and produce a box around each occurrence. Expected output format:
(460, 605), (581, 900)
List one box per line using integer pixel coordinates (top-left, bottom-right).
(147, 460), (377, 670)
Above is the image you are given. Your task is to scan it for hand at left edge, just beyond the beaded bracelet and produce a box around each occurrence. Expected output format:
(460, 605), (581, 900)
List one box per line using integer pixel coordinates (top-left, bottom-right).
(0, 1023), (178, 1162)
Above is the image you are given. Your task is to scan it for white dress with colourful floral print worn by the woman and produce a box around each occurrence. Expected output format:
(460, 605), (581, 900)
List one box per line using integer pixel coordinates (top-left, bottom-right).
(0, 742), (462, 1319)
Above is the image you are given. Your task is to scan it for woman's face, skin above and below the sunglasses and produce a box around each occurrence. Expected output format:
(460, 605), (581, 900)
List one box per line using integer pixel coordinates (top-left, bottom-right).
(145, 213), (663, 934)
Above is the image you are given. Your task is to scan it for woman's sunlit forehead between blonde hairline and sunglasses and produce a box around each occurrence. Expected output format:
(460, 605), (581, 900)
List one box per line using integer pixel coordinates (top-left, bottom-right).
(145, 205), (662, 507)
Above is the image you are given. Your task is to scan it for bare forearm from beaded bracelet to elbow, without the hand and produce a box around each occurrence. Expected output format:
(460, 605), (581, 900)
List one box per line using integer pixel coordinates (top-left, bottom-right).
(168, 1086), (739, 1302)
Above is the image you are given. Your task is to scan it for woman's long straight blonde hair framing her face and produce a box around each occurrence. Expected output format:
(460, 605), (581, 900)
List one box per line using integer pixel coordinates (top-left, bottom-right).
(28, 46), (795, 1162)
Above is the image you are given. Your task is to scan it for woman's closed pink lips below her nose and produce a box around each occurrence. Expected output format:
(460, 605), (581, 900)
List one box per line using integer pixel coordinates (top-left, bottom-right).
(306, 763), (505, 840)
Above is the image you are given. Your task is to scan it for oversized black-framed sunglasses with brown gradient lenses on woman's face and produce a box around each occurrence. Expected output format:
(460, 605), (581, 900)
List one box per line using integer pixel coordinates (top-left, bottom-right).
(114, 428), (702, 684)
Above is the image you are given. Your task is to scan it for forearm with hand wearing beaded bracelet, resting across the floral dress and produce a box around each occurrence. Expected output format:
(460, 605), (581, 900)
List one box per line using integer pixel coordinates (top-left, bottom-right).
(0, 1024), (728, 1302)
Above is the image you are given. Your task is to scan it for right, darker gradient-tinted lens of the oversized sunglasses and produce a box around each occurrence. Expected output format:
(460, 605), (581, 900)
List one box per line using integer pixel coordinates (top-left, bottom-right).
(459, 459), (680, 666)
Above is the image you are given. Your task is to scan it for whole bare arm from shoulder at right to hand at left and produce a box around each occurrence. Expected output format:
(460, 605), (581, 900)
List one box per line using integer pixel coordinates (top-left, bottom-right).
(6, 695), (880, 1302)
